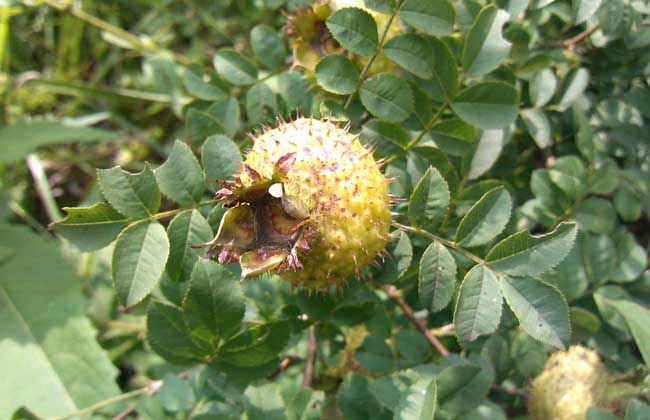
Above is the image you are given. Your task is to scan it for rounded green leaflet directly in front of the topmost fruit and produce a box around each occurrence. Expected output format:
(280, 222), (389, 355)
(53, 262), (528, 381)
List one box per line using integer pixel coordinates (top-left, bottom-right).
(325, 7), (379, 55)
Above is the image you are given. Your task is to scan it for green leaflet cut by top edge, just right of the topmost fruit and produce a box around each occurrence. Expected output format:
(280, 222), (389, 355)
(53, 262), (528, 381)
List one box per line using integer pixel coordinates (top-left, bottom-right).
(399, 0), (456, 36)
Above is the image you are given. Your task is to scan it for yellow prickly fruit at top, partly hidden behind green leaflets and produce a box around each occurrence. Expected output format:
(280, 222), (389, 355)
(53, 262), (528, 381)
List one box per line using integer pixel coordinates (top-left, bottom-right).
(287, 0), (402, 77)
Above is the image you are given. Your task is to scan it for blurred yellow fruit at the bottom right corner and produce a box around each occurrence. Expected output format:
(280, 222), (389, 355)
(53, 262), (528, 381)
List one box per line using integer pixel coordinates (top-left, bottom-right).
(529, 346), (610, 420)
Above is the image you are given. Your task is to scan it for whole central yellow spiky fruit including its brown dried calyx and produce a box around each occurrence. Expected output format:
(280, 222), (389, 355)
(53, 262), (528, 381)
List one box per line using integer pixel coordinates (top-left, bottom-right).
(199, 118), (391, 290)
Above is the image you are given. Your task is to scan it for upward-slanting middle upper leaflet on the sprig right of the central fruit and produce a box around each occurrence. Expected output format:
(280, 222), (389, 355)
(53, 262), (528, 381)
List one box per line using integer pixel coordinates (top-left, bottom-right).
(456, 187), (512, 247)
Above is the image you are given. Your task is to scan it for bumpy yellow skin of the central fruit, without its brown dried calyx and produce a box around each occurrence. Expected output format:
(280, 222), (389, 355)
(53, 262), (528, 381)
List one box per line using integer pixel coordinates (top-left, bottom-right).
(241, 118), (391, 289)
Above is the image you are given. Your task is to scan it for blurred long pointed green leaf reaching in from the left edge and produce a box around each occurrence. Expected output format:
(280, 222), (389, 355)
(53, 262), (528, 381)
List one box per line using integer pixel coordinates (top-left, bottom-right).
(0, 121), (117, 163)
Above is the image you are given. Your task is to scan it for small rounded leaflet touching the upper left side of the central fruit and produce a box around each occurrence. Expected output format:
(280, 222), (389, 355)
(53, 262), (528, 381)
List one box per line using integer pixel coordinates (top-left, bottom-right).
(201, 135), (242, 185)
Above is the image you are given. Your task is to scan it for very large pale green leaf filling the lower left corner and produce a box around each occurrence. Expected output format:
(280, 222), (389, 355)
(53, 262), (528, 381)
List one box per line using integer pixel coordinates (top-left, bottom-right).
(0, 225), (120, 418)
